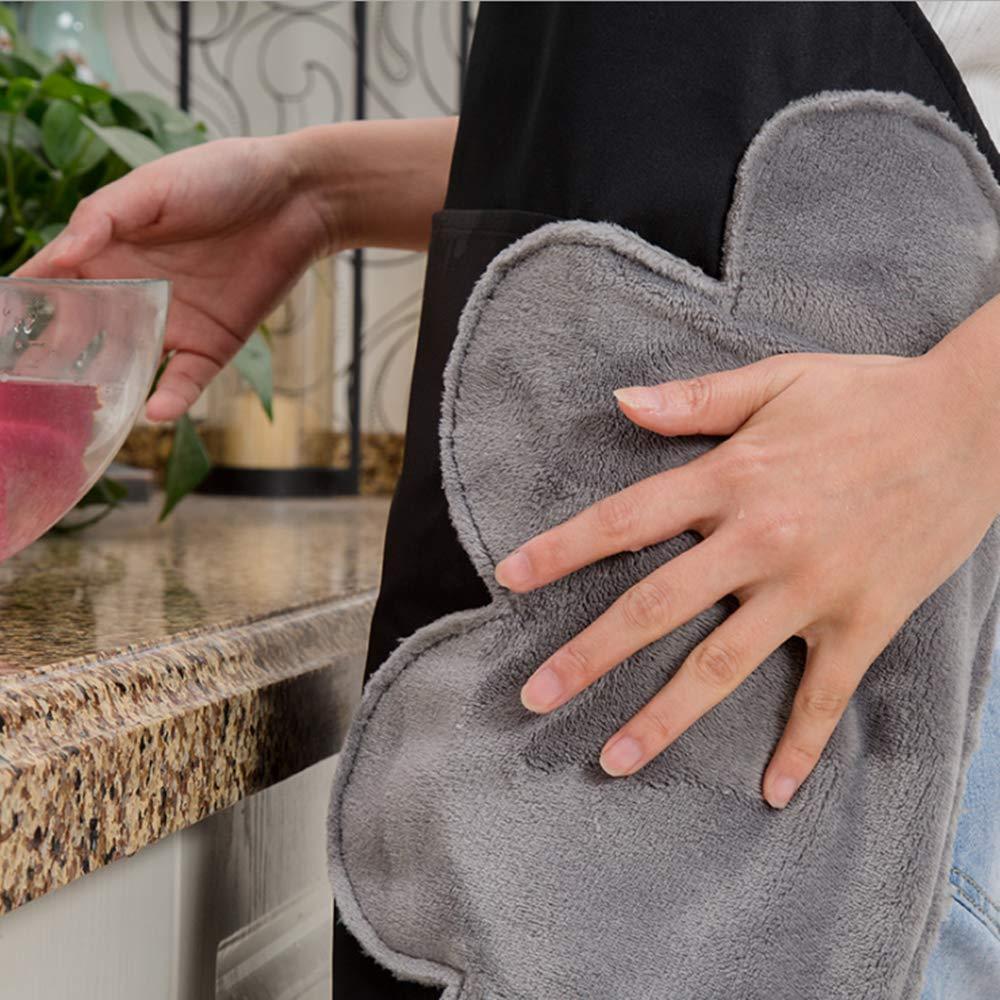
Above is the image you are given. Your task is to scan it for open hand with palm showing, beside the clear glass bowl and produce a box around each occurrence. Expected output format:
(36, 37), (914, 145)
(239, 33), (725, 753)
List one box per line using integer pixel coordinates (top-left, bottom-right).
(16, 137), (341, 420)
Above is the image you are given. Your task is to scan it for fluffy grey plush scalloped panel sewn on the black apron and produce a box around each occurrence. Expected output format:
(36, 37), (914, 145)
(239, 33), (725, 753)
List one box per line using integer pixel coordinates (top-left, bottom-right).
(330, 91), (1000, 1000)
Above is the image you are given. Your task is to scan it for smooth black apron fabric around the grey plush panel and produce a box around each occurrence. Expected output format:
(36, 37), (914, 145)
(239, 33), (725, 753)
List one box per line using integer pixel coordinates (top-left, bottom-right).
(333, 3), (1000, 1000)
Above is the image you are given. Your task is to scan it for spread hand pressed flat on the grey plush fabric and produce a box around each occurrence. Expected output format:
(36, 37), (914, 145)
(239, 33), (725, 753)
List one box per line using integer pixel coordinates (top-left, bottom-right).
(496, 350), (1000, 808)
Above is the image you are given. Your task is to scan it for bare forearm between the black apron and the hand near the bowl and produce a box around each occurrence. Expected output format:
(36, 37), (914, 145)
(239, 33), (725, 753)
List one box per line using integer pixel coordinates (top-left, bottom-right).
(275, 118), (458, 252)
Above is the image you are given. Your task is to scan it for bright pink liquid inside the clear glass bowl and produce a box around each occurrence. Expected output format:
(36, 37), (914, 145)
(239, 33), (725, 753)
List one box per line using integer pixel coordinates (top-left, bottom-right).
(0, 379), (100, 561)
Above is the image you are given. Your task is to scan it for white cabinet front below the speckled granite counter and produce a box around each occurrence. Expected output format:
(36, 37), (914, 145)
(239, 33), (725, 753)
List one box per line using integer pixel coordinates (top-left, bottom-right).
(0, 758), (334, 1000)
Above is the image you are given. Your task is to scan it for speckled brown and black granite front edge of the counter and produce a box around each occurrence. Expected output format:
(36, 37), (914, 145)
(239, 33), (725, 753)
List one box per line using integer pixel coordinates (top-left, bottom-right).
(0, 591), (375, 912)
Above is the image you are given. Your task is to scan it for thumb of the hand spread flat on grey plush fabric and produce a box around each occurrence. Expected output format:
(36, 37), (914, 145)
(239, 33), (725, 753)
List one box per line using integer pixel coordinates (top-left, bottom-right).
(614, 355), (801, 434)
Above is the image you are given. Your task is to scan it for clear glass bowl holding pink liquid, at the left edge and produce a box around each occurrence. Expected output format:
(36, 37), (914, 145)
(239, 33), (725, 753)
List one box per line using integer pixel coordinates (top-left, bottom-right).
(0, 278), (170, 561)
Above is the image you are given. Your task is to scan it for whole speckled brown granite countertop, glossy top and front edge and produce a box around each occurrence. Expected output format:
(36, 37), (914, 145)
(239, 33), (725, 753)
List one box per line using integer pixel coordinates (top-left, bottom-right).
(0, 496), (388, 912)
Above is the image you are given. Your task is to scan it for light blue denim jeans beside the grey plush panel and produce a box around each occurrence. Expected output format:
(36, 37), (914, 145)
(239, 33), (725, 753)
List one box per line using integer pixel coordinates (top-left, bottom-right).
(921, 632), (1000, 1000)
